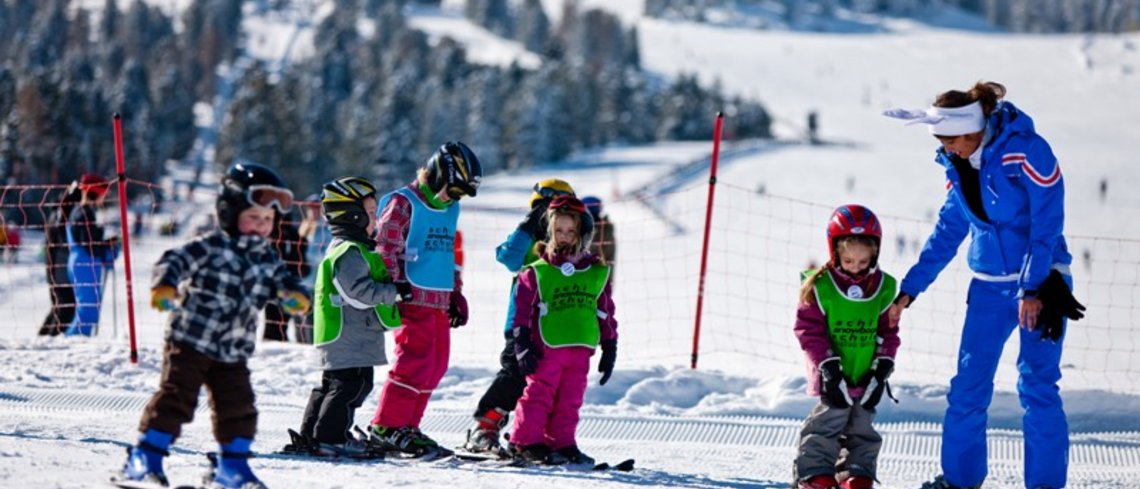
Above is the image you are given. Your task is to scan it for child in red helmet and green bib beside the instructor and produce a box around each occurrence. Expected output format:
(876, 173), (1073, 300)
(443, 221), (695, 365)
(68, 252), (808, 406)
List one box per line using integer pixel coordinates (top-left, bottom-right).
(795, 205), (899, 489)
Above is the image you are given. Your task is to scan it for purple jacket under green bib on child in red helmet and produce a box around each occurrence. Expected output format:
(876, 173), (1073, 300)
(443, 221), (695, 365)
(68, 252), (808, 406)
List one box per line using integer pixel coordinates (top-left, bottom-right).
(796, 267), (899, 399)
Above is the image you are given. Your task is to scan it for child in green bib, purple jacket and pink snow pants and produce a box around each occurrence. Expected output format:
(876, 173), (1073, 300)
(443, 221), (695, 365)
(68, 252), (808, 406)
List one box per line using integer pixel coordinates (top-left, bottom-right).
(510, 196), (618, 466)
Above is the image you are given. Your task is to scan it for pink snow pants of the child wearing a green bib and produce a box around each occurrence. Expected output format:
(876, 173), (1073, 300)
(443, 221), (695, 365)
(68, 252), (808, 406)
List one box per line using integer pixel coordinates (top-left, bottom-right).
(511, 347), (594, 450)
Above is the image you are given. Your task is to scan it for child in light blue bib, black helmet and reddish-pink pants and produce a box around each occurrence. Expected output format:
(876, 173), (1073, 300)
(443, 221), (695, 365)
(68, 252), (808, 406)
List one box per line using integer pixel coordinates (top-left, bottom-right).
(369, 141), (483, 457)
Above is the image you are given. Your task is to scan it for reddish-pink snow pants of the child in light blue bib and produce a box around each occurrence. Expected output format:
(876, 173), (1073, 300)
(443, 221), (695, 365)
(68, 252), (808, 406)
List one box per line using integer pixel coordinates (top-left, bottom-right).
(372, 304), (451, 427)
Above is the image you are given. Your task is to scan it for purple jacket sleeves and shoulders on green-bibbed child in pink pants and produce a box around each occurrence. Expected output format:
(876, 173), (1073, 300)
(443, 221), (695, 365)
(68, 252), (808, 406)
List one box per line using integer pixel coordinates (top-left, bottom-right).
(511, 252), (618, 350)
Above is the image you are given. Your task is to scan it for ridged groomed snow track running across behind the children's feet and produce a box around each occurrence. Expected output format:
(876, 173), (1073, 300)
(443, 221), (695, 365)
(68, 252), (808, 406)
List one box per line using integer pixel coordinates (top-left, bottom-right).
(0, 388), (1140, 488)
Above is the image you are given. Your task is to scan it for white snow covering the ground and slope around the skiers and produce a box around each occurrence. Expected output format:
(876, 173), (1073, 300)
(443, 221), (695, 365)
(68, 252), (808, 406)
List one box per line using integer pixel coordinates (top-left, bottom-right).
(0, 1), (1140, 489)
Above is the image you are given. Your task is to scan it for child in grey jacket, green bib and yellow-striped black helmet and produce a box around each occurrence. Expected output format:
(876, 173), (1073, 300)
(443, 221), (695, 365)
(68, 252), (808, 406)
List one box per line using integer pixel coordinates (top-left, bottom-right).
(286, 177), (400, 457)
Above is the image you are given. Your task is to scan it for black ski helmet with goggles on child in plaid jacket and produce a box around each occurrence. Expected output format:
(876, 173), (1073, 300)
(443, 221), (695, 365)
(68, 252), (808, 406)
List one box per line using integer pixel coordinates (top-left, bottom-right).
(214, 162), (293, 236)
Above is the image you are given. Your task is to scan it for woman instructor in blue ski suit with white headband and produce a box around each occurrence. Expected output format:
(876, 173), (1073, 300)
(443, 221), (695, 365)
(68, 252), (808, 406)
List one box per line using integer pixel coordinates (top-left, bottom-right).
(885, 82), (1084, 489)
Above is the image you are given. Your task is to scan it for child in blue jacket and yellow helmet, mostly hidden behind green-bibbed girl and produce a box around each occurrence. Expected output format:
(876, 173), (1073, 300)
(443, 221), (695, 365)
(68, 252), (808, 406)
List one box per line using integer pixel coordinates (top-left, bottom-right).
(463, 178), (575, 454)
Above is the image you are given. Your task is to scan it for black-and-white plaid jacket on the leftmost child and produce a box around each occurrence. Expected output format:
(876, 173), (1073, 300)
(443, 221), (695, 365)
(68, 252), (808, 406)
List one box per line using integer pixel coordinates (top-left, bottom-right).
(152, 230), (311, 362)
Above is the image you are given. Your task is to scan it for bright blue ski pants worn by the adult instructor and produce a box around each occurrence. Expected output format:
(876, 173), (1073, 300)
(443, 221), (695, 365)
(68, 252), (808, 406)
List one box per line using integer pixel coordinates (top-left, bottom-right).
(942, 277), (1072, 488)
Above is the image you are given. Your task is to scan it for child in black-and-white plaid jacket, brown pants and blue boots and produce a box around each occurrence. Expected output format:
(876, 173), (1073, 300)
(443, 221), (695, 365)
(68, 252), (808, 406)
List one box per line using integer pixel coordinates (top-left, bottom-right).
(116, 163), (309, 489)
